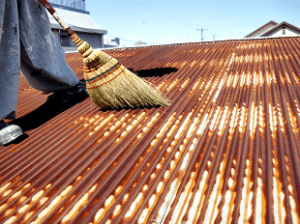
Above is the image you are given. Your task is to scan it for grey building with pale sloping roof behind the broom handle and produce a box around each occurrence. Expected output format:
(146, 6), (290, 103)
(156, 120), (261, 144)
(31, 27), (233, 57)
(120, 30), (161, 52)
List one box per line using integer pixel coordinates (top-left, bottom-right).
(48, 3), (107, 51)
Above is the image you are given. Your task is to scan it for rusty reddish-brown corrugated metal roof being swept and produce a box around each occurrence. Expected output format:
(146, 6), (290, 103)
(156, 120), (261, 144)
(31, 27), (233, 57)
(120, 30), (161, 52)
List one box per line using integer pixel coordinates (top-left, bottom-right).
(0, 37), (300, 224)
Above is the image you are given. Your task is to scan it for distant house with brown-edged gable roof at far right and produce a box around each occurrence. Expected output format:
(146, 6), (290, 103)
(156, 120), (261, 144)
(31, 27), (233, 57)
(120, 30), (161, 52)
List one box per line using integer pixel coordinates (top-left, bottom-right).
(245, 20), (300, 38)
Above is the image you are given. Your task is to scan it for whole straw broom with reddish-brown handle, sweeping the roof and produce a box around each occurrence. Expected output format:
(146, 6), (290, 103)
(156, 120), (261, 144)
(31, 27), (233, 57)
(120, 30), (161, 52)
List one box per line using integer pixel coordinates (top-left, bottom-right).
(39, 0), (169, 109)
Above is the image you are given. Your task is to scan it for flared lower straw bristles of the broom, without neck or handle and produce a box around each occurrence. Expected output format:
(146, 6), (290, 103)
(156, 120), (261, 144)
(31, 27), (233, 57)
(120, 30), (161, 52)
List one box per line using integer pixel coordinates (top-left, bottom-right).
(86, 60), (169, 109)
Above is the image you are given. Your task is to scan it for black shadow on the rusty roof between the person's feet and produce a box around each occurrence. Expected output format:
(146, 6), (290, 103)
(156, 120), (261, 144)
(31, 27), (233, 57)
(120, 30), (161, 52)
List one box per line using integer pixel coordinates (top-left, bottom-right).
(10, 79), (88, 144)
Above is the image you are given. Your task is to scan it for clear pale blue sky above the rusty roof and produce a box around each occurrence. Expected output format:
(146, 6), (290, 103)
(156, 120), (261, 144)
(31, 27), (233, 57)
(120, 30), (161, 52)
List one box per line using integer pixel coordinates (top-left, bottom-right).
(86, 0), (300, 45)
